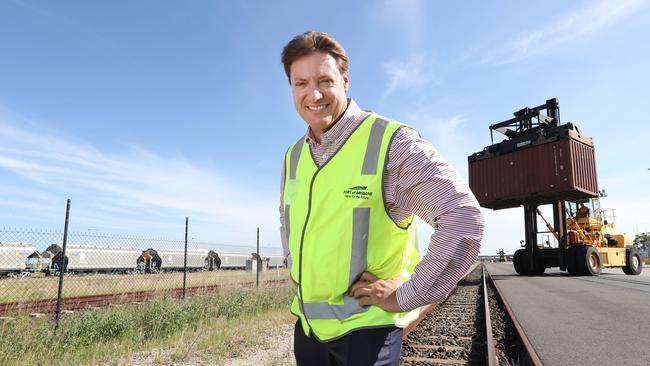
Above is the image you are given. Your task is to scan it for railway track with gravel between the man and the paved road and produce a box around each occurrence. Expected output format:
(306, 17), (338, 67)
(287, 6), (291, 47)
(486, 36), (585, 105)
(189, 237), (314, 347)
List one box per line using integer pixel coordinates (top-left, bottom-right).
(401, 265), (541, 366)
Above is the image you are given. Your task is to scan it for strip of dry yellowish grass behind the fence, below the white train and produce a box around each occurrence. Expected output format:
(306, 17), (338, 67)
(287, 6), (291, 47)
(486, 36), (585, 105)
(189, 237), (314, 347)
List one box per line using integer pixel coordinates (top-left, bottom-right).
(0, 269), (289, 303)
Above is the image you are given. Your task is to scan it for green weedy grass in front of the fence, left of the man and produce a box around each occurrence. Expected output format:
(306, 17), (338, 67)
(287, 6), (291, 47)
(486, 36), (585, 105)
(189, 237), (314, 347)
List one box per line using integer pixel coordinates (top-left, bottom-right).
(0, 285), (295, 365)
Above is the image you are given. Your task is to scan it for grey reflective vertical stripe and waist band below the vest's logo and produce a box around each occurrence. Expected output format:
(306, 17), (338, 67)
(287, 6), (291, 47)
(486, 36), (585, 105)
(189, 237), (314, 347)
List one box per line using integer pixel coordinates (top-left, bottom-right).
(299, 207), (370, 320)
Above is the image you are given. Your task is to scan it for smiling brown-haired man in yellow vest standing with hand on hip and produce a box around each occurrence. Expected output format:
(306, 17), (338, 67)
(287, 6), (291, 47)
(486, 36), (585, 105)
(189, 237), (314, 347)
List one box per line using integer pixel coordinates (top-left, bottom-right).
(280, 31), (483, 365)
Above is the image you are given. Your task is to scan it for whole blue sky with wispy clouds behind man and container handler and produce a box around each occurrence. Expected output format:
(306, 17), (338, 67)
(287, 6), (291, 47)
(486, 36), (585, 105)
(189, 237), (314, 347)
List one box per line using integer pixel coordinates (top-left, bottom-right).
(0, 0), (650, 254)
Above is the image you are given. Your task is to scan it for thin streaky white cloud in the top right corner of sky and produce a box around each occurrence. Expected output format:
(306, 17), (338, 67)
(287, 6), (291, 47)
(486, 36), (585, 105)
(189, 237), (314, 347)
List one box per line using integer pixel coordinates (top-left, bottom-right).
(481, 0), (646, 63)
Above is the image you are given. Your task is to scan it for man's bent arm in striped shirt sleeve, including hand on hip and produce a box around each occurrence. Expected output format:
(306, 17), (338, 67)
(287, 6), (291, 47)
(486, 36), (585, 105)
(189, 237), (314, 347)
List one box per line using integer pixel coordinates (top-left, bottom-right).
(350, 128), (484, 311)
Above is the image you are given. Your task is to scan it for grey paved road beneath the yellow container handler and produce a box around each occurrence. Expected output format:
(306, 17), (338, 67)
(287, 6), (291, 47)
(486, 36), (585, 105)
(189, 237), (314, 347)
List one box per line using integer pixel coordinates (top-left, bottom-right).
(486, 263), (650, 365)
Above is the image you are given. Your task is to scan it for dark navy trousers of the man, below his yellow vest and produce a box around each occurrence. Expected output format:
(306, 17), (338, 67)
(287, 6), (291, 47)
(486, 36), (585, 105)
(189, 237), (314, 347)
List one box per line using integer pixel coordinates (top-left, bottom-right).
(293, 320), (402, 366)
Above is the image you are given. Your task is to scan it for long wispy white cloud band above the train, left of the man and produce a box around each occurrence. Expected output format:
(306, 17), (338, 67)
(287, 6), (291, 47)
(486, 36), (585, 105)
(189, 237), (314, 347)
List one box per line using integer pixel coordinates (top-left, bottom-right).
(0, 117), (279, 243)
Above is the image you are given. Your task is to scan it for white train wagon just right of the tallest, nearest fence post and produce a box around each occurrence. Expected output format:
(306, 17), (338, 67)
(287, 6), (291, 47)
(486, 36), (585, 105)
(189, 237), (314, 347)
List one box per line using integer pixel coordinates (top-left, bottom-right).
(66, 245), (142, 272)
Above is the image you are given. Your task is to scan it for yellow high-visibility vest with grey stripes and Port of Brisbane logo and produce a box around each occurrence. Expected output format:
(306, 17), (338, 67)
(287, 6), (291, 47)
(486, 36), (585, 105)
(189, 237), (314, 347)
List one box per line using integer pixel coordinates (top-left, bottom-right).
(283, 114), (420, 341)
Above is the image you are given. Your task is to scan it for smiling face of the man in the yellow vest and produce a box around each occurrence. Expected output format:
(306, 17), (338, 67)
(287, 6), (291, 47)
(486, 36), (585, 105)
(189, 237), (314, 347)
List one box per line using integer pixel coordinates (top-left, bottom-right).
(291, 52), (348, 138)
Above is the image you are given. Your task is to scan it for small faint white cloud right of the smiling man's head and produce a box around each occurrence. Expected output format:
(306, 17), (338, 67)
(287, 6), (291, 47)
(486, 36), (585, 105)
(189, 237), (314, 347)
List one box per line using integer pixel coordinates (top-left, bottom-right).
(382, 54), (434, 98)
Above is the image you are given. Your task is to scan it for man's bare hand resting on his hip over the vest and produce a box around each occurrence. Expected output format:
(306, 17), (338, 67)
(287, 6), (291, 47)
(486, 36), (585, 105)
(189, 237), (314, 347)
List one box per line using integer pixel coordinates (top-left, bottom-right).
(348, 272), (402, 313)
